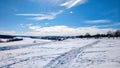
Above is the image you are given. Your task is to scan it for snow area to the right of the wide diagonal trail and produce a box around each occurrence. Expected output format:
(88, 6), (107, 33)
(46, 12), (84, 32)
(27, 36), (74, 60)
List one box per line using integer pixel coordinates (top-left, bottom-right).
(71, 39), (120, 68)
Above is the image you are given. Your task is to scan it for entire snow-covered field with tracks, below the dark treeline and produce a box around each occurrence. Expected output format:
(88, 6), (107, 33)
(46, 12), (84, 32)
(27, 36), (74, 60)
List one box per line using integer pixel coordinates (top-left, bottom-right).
(0, 38), (120, 68)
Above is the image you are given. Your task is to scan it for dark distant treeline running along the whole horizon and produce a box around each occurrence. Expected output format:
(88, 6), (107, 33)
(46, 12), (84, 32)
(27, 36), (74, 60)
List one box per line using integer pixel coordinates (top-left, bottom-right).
(0, 30), (120, 41)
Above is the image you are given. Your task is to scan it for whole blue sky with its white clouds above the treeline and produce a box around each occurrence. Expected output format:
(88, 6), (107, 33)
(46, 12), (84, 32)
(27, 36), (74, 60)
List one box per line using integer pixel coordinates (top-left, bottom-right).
(0, 0), (120, 36)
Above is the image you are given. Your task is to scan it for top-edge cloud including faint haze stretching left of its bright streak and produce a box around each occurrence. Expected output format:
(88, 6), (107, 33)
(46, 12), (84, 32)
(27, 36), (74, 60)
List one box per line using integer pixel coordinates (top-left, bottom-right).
(29, 0), (87, 8)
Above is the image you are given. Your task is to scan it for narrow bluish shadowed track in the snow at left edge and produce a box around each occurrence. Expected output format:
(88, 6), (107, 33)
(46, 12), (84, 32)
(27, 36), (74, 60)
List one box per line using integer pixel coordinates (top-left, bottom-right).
(0, 42), (51, 51)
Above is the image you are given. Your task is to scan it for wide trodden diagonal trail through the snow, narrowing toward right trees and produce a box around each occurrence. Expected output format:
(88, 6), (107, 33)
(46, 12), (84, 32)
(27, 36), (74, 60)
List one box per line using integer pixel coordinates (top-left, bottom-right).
(43, 40), (100, 68)
